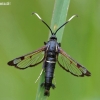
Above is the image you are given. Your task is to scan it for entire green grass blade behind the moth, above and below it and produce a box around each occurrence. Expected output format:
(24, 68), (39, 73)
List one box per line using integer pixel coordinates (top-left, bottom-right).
(36, 0), (70, 100)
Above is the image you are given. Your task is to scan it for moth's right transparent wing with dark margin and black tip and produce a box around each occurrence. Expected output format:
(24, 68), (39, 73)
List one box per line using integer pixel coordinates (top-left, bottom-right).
(57, 48), (91, 77)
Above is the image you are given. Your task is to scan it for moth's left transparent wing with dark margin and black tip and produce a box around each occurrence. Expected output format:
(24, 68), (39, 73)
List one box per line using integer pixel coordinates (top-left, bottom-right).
(7, 46), (46, 69)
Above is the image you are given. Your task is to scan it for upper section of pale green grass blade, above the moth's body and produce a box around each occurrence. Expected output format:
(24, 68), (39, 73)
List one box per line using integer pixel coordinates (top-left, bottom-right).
(50, 0), (70, 42)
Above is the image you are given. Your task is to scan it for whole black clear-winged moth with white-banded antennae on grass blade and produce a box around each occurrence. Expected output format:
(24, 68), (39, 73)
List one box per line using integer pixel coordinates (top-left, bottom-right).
(8, 13), (91, 96)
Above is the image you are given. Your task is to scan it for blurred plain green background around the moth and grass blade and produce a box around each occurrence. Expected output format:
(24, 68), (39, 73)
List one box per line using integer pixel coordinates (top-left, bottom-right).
(0, 0), (100, 100)
